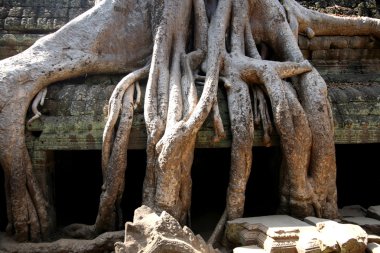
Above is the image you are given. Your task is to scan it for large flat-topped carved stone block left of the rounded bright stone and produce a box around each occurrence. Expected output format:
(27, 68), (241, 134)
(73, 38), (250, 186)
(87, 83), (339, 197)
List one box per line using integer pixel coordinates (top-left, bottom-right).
(226, 215), (320, 253)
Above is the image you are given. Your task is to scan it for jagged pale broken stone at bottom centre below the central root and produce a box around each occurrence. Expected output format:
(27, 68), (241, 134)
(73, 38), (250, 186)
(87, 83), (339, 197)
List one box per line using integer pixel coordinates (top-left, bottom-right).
(115, 206), (219, 253)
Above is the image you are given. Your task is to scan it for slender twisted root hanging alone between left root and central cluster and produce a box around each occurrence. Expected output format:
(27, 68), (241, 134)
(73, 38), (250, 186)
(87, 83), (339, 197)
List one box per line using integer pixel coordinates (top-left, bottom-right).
(95, 66), (149, 234)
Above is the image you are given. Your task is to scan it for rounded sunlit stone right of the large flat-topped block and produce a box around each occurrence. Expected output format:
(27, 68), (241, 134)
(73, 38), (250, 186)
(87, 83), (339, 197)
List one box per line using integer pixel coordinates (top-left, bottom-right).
(317, 221), (367, 253)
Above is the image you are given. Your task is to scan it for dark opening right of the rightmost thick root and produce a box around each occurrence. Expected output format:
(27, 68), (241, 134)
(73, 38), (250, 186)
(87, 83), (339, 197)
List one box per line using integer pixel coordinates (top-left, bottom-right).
(336, 143), (380, 208)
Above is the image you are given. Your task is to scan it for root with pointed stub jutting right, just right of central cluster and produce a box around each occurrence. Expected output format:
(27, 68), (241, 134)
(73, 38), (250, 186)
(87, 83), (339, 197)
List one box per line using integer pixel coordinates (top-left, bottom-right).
(203, 0), (312, 243)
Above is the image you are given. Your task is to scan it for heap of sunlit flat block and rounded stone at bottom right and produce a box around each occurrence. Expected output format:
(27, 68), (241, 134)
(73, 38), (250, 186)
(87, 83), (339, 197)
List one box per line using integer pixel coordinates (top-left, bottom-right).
(225, 215), (368, 253)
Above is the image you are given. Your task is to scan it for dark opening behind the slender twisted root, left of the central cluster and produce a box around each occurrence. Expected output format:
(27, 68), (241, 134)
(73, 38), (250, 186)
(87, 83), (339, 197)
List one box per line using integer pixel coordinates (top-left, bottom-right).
(55, 150), (146, 227)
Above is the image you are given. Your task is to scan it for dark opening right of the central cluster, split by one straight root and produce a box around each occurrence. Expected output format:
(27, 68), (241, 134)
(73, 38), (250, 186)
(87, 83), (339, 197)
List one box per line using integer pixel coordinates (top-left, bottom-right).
(191, 147), (281, 238)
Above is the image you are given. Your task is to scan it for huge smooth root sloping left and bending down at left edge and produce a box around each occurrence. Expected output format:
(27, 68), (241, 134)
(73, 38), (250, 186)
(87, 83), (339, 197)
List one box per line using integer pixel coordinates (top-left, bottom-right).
(0, 1), (151, 241)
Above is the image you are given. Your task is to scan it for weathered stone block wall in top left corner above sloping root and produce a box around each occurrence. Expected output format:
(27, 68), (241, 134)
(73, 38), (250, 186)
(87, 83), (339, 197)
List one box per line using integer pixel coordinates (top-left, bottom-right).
(0, 0), (94, 59)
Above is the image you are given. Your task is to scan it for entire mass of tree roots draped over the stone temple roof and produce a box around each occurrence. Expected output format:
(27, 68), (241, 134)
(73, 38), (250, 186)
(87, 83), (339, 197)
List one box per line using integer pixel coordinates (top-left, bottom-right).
(0, 0), (380, 241)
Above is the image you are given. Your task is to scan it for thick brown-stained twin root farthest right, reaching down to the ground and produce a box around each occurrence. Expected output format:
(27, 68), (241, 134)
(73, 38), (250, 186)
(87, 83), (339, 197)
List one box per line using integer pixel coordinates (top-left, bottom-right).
(252, 0), (343, 218)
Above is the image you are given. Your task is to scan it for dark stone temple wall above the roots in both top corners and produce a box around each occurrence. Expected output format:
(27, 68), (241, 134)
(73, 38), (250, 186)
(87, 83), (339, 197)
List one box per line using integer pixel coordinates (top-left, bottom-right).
(0, 0), (380, 60)
